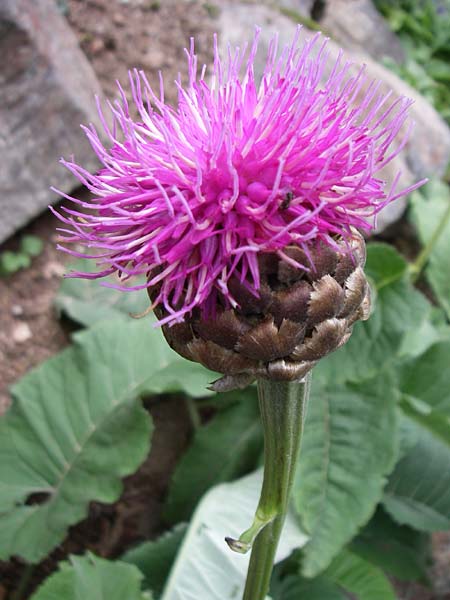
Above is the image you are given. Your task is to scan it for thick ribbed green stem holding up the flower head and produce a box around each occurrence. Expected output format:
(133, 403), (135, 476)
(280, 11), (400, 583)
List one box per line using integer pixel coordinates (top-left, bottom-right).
(227, 374), (311, 600)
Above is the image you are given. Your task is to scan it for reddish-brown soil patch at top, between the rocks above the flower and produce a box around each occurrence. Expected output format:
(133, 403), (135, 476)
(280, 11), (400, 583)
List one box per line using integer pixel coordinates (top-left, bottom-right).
(67, 0), (218, 109)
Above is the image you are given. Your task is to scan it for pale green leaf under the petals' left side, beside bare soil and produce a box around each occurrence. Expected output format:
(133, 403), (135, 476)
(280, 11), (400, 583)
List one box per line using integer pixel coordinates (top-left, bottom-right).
(55, 258), (150, 327)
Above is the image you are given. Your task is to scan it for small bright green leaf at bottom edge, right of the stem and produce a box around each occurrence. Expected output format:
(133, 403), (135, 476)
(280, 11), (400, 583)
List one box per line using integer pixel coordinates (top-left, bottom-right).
(324, 550), (397, 600)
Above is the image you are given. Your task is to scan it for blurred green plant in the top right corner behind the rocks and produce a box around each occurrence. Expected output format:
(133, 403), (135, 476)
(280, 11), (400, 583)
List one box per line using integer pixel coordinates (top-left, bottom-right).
(375, 0), (450, 123)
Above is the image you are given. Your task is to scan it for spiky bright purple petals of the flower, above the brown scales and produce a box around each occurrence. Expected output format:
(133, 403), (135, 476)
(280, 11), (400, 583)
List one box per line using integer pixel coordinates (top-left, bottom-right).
(54, 30), (420, 324)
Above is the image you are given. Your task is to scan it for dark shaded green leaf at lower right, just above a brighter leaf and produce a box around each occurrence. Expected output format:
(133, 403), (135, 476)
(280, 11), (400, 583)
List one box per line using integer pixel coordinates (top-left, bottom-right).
(350, 507), (431, 583)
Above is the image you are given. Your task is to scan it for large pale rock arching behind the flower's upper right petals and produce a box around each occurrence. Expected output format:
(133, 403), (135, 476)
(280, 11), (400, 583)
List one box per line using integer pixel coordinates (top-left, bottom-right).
(219, 3), (450, 231)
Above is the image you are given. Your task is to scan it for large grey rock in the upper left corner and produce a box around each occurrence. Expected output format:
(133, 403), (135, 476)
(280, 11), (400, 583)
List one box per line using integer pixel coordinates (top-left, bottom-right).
(0, 0), (101, 241)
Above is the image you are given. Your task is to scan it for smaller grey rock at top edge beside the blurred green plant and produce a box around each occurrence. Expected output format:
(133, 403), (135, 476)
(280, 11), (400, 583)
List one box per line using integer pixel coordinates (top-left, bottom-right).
(320, 0), (405, 63)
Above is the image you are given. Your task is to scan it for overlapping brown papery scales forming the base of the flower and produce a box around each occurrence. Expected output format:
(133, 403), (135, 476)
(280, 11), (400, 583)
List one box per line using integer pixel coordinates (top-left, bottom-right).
(149, 232), (370, 391)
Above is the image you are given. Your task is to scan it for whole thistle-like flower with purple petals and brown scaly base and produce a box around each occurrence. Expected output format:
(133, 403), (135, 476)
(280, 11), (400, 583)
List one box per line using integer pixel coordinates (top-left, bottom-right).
(54, 27), (420, 389)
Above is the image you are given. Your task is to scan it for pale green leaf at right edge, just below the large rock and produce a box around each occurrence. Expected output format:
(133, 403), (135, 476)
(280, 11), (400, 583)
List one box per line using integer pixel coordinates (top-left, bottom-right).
(411, 180), (450, 318)
